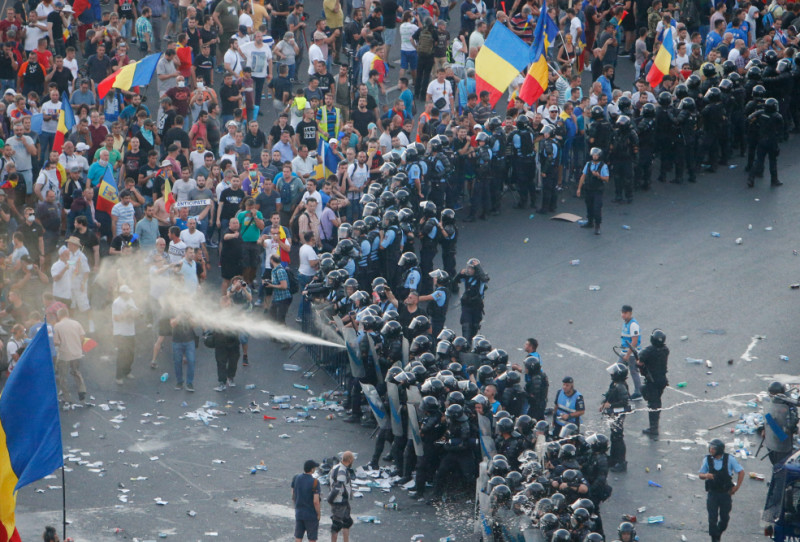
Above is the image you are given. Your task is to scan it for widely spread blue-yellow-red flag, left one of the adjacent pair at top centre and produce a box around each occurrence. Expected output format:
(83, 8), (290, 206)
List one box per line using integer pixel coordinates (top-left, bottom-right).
(475, 24), (528, 107)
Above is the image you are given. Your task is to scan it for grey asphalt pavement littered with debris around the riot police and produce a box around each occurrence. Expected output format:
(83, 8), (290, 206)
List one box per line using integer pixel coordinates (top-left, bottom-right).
(12, 5), (800, 542)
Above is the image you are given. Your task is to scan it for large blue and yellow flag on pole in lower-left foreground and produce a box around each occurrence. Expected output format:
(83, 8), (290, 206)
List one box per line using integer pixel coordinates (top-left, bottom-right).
(0, 326), (64, 542)
